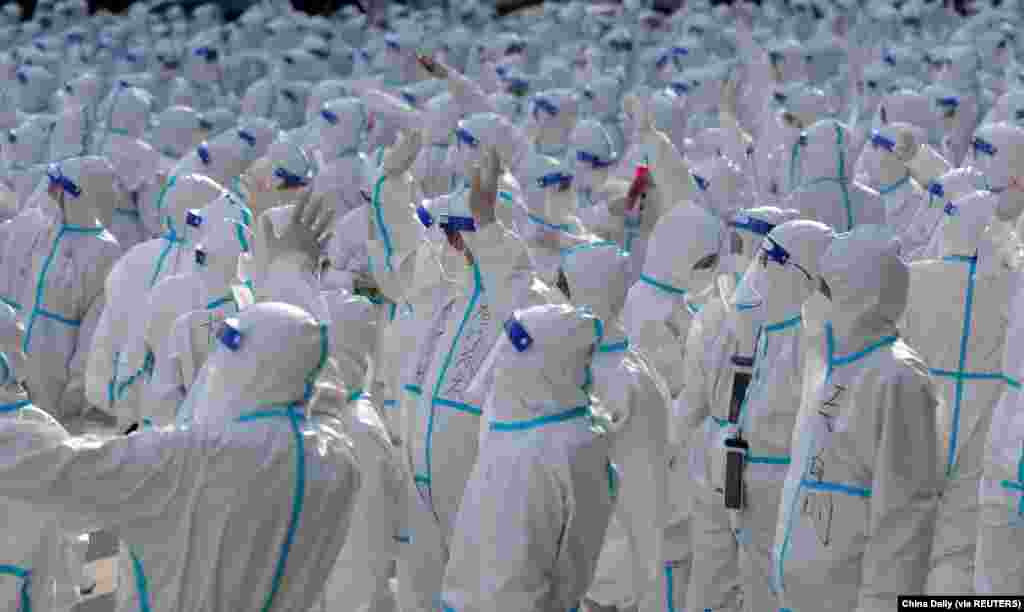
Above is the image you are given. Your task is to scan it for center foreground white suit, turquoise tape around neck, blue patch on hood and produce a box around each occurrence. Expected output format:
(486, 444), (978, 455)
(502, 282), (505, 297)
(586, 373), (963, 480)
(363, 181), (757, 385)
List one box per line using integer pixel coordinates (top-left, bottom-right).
(440, 305), (611, 612)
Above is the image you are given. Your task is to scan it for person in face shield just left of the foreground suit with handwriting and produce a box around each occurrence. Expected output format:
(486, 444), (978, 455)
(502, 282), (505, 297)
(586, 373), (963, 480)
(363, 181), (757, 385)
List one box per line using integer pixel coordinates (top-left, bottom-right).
(712, 220), (833, 610)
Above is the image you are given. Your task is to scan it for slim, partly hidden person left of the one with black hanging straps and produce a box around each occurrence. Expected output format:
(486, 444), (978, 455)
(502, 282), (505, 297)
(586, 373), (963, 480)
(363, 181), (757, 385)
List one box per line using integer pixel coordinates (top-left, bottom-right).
(673, 207), (798, 610)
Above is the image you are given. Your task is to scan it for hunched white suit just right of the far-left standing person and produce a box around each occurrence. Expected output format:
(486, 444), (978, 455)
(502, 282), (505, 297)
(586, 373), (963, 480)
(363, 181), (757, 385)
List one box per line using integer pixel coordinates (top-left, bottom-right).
(85, 174), (227, 425)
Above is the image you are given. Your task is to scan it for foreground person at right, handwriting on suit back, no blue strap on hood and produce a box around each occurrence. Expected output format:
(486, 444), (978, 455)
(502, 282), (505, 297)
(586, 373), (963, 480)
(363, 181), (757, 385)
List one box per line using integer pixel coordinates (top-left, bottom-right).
(772, 225), (940, 612)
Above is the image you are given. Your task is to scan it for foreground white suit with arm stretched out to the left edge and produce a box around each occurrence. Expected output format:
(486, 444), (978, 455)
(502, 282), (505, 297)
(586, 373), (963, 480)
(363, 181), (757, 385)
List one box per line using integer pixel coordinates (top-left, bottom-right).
(0, 303), (360, 612)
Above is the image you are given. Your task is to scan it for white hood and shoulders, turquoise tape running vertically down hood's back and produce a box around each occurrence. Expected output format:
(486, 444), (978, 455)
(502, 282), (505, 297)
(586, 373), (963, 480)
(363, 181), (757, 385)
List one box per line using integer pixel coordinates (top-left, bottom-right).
(785, 120), (886, 231)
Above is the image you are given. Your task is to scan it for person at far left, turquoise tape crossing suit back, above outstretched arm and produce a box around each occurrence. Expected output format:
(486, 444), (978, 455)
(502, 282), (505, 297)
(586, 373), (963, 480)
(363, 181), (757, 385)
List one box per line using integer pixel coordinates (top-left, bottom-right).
(23, 158), (121, 433)
